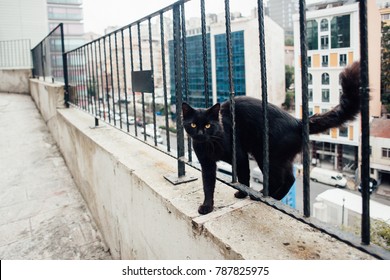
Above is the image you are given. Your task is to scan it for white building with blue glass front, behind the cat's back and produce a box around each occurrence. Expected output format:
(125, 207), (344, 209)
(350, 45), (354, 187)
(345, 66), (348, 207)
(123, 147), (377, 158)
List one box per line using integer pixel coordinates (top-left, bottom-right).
(169, 13), (285, 107)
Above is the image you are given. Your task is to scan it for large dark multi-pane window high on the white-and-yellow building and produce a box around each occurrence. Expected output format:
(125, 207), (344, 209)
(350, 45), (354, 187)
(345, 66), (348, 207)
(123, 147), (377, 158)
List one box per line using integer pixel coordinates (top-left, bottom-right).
(331, 15), (351, 49)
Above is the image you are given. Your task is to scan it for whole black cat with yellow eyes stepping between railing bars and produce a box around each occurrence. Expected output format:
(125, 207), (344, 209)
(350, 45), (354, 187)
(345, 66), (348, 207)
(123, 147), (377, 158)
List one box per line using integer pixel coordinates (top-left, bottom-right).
(182, 62), (360, 214)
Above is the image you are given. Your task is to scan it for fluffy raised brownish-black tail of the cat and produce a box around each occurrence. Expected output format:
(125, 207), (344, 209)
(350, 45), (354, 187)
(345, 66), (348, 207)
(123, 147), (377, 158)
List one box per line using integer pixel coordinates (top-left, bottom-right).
(309, 62), (360, 134)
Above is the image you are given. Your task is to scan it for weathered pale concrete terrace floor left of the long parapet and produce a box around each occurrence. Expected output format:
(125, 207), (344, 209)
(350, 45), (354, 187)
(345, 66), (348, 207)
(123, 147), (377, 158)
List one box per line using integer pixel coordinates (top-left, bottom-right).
(0, 93), (111, 259)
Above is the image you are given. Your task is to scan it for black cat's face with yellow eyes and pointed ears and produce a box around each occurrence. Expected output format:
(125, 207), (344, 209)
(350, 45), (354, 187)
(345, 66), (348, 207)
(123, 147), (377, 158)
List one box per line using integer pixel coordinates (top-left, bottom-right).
(182, 103), (221, 142)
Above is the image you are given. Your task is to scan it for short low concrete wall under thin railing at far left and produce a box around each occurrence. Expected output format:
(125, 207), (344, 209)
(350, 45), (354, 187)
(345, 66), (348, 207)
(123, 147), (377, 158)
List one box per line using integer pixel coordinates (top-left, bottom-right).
(0, 69), (32, 94)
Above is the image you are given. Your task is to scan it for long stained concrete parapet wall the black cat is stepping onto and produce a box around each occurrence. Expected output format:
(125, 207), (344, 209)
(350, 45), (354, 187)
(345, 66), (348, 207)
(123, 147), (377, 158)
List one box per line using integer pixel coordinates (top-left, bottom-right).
(31, 77), (371, 259)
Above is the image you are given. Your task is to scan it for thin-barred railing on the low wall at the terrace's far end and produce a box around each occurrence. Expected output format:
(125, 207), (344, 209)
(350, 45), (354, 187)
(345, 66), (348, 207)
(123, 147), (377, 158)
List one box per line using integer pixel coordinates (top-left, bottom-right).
(0, 39), (32, 69)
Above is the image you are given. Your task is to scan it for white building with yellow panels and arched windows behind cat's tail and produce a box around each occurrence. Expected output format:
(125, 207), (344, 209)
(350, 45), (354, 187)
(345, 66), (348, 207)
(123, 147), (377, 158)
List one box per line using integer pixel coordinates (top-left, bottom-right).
(294, 0), (381, 172)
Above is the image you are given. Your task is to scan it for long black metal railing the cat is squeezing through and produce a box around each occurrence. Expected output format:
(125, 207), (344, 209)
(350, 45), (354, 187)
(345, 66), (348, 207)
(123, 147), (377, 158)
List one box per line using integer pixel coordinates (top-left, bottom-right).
(33, 0), (389, 258)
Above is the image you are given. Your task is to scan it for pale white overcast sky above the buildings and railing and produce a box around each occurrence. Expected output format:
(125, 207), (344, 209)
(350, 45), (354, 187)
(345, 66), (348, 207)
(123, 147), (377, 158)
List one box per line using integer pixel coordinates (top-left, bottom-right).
(83, 0), (319, 34)
